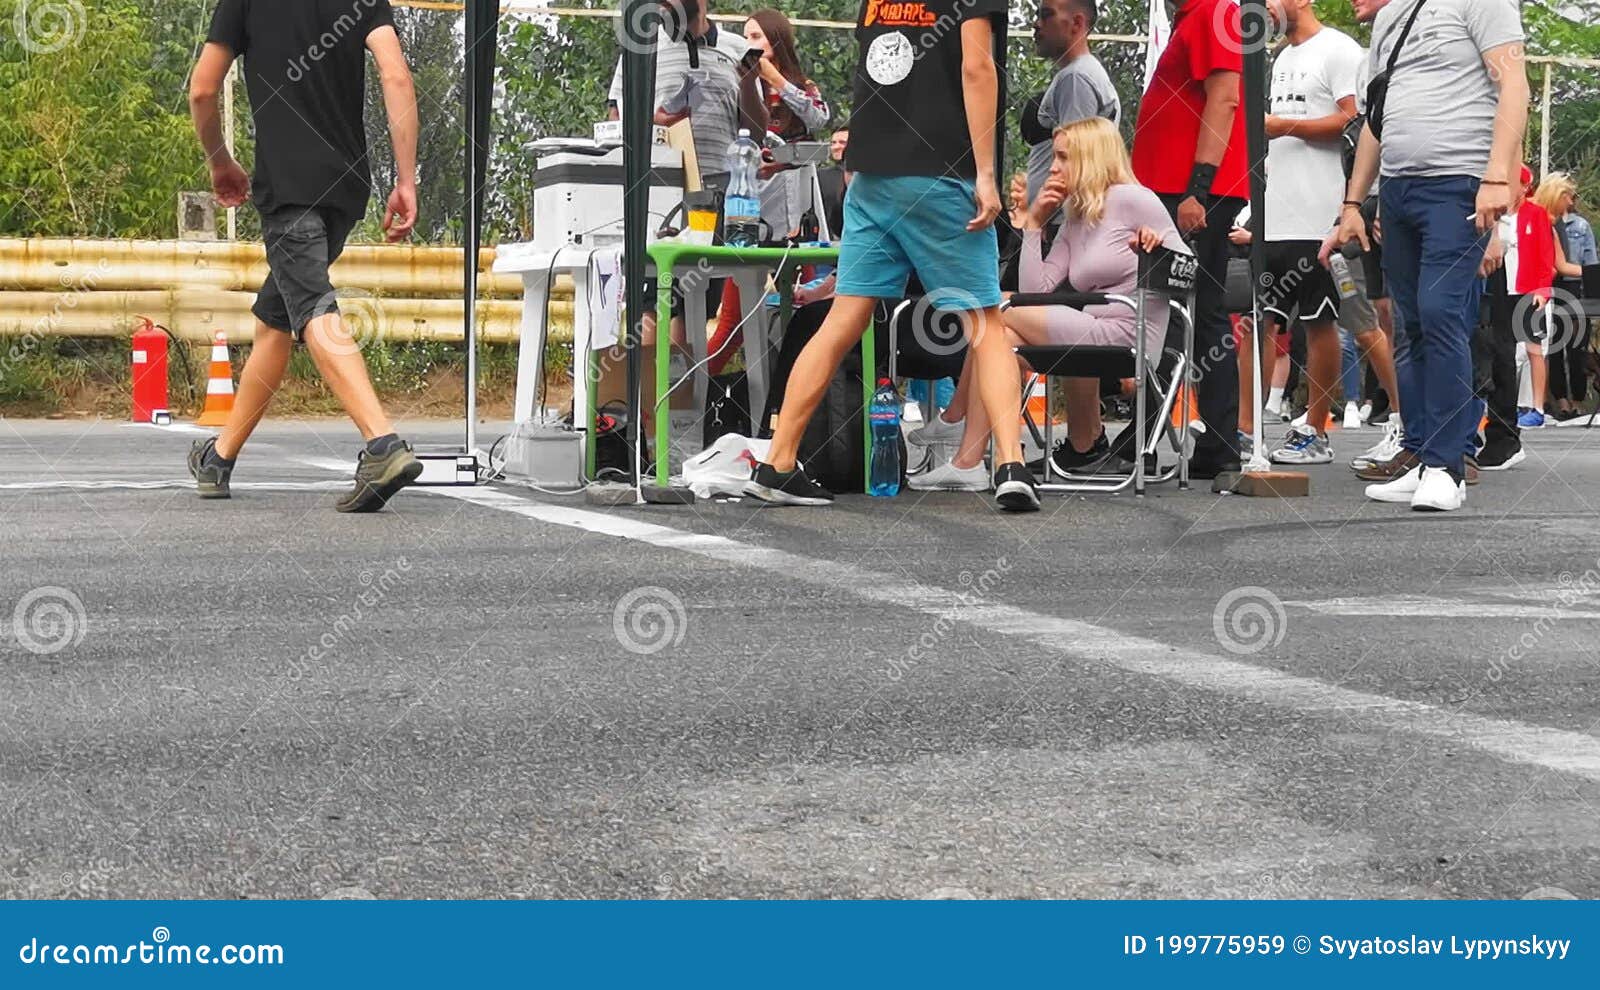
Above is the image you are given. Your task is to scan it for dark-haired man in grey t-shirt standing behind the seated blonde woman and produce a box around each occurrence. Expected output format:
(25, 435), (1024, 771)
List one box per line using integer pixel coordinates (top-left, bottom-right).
(1022, 0), (1122, 200)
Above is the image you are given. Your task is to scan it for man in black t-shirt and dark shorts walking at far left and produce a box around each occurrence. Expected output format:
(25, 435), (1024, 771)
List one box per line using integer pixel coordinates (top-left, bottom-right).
(189, 0), (422, 512)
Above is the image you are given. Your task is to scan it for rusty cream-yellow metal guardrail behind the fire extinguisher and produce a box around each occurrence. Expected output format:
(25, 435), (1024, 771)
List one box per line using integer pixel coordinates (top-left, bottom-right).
(0, 238), (573, 342)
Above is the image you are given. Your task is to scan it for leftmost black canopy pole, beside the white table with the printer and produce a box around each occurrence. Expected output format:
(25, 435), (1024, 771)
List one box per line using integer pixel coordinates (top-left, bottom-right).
(461, 0), (499, 454)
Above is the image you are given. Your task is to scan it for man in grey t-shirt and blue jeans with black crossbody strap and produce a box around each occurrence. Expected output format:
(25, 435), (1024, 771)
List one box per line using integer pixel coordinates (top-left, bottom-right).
(1322, 0), (1528, 512)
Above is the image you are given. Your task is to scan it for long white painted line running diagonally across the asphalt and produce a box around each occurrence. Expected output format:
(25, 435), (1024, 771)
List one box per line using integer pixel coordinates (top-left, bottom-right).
(416, 488), (1600, 780)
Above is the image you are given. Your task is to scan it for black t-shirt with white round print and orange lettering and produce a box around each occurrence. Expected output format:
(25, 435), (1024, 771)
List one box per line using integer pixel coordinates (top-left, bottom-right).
(845, 0), (1006, 179)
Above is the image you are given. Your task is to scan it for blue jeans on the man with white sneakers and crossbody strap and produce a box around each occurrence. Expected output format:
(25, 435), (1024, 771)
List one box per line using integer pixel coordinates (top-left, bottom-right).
(1379, 176), (1488, 478)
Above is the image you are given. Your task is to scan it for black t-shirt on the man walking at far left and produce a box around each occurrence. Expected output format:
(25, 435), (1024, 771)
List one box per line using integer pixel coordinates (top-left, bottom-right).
(206, 0), (394, 219)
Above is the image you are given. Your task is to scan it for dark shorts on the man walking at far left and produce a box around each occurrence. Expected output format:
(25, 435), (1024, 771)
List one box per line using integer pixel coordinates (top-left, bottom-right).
(250, 206), (355, 341)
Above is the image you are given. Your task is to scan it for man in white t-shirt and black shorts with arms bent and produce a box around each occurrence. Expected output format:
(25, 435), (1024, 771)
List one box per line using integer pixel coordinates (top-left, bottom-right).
(1261, 0), (1362, 464)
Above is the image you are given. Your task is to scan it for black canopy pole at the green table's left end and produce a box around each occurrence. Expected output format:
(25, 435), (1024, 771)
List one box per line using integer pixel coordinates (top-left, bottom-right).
(617, 0), (667, 486)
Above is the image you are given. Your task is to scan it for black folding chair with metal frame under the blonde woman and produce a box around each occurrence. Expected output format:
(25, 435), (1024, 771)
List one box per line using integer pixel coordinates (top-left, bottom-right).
(1005, 248), (1198, 496)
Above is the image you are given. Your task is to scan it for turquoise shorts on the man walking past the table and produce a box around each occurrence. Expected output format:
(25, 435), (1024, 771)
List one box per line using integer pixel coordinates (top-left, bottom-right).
(835, 173), (1000, 310)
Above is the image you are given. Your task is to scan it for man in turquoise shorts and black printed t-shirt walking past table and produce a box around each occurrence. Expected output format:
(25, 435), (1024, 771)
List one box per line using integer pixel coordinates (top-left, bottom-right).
(744, 0), (1038, 512)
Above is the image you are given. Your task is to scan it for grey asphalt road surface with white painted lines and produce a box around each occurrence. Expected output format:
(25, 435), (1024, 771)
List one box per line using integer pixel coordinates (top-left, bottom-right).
(0, 421), (1600, 897)
